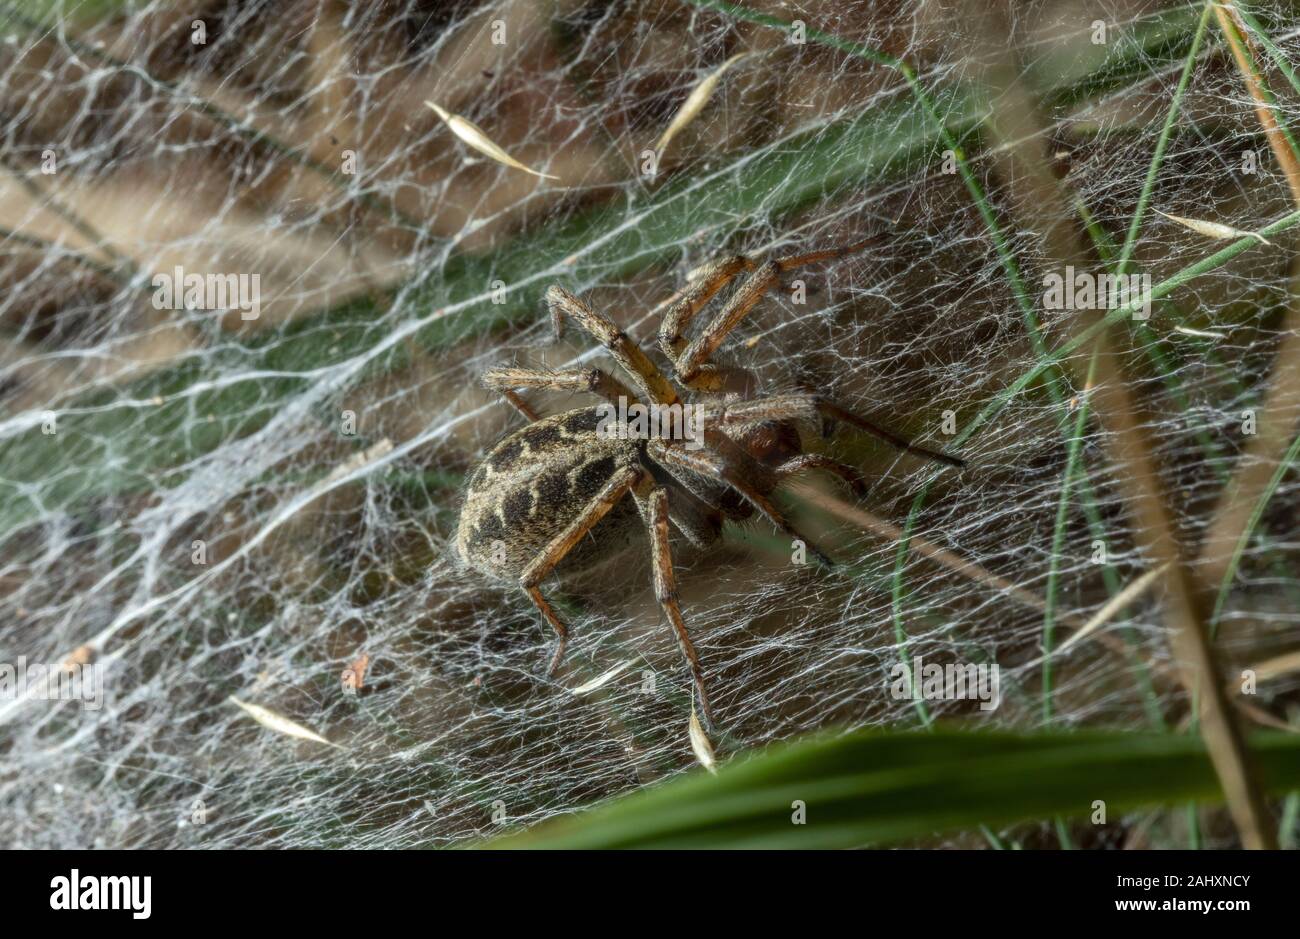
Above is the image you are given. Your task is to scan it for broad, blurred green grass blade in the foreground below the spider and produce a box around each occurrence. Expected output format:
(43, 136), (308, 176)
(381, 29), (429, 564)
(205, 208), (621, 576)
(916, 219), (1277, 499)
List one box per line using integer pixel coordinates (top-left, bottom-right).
(488, 728), (1300, 849)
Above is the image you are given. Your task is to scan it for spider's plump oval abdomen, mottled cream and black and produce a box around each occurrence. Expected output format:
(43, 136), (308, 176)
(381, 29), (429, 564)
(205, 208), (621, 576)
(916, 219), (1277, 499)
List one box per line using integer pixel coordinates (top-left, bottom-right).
(456, 407), (641, 579)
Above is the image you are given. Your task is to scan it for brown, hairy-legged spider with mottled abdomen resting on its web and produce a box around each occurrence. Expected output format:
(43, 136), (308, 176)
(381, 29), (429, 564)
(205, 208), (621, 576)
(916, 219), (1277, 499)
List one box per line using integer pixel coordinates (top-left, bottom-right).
(456, 242), (965, 726)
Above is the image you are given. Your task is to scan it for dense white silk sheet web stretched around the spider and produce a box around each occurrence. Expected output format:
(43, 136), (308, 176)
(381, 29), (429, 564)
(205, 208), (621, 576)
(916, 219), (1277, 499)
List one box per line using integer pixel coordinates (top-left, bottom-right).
(0, 0), (1300, 847)
